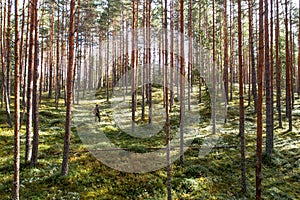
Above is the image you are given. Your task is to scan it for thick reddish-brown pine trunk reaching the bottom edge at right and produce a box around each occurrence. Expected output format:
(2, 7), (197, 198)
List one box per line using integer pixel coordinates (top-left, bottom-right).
(256, 0), (264, 200)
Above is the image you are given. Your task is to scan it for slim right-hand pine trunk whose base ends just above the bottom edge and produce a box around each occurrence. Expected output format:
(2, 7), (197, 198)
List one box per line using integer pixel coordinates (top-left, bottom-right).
(238, 1), (247, 192)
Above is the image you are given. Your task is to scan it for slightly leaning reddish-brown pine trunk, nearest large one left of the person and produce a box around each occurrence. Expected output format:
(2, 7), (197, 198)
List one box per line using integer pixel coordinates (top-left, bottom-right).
(62, 0), (75, 175)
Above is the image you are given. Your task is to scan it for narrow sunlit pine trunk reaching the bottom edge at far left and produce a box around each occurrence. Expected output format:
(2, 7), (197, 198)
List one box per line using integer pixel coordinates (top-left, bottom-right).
(14, 0), (20, 200)
